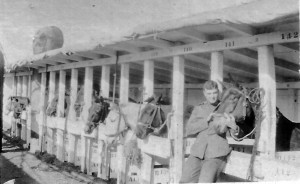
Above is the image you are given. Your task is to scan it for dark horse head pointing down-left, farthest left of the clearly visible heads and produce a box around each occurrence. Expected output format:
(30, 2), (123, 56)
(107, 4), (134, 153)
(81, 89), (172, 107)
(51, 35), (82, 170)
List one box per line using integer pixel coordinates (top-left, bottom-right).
(84, 96), (110, 134)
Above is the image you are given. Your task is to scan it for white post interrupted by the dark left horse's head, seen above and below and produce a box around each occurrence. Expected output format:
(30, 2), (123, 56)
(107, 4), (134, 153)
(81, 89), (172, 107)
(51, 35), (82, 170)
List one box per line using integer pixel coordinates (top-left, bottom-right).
(98, 65), (110, 179)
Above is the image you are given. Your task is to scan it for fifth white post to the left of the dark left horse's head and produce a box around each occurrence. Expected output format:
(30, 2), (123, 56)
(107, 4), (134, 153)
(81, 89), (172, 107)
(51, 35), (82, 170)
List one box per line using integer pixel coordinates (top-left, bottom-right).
(39, 72), (47, 151)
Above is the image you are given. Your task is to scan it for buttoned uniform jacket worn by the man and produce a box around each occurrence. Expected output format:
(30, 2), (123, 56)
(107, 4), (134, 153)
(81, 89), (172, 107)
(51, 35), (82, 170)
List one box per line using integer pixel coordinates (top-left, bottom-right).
(186, 102), (240, 159)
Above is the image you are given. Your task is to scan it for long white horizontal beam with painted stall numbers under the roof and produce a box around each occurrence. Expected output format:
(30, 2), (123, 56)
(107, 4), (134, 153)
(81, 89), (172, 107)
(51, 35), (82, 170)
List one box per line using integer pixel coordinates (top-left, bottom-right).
(39, 31), (299, 72)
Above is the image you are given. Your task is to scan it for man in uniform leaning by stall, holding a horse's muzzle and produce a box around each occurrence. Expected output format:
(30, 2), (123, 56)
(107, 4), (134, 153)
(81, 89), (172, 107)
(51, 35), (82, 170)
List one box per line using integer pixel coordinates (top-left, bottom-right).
(180, 81), (239, 183)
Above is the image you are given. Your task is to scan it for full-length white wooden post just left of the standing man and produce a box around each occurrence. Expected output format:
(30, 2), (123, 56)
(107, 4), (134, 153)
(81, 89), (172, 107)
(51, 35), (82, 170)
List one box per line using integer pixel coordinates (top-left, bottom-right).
(170, 56), (184, 183)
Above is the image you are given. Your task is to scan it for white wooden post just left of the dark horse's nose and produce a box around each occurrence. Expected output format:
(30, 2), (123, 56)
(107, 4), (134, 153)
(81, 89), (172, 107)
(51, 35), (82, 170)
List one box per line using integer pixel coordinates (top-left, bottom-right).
(81, 67), (93, 172)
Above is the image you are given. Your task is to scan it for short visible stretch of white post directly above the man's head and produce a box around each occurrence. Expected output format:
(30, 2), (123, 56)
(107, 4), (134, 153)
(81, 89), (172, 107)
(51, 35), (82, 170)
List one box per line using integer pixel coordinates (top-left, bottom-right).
(210, 51), (224, 92)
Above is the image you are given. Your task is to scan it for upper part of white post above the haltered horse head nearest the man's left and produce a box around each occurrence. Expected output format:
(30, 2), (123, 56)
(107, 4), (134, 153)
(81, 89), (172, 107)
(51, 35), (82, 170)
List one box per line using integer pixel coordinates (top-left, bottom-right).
(143, 60), (154, 100)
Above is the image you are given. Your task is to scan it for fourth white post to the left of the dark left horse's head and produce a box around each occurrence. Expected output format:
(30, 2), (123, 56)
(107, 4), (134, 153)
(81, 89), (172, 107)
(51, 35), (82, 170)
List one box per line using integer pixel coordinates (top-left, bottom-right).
(46, 72), (57, 154)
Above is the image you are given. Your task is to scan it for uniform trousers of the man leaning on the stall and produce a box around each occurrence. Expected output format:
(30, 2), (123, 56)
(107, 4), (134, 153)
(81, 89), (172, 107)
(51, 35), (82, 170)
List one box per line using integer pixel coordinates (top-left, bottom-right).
(180, 155), (227, 183)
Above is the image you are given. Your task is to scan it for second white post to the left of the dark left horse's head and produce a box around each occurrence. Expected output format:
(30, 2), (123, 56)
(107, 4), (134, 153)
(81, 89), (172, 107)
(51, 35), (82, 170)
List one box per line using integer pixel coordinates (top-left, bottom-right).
(68, 69), (78, 163)
